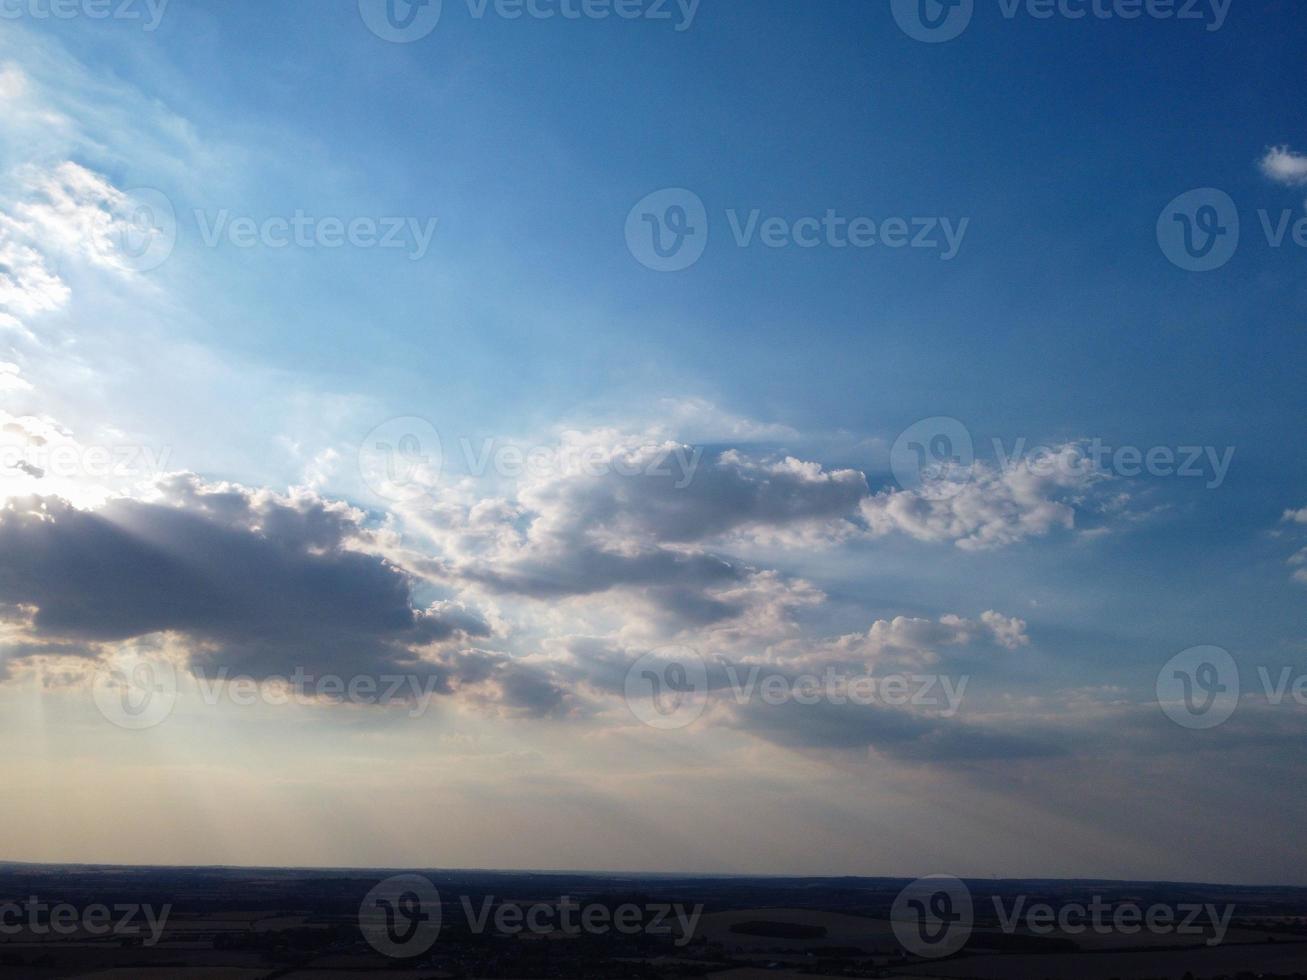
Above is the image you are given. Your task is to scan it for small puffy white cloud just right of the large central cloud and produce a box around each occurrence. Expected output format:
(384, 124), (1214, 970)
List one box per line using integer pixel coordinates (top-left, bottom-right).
(861, 444), (1108, 551)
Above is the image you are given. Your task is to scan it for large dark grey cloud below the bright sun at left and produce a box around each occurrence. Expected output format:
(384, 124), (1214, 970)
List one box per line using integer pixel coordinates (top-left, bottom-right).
(0, 476), (490, 678)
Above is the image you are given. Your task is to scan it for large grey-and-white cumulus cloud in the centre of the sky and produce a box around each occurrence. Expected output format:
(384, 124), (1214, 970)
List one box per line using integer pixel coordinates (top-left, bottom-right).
(414, 443), (867, 626)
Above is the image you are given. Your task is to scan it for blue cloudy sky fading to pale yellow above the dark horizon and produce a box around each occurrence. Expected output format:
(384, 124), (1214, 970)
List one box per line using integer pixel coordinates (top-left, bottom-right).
(0, 0), (1307, 885)
